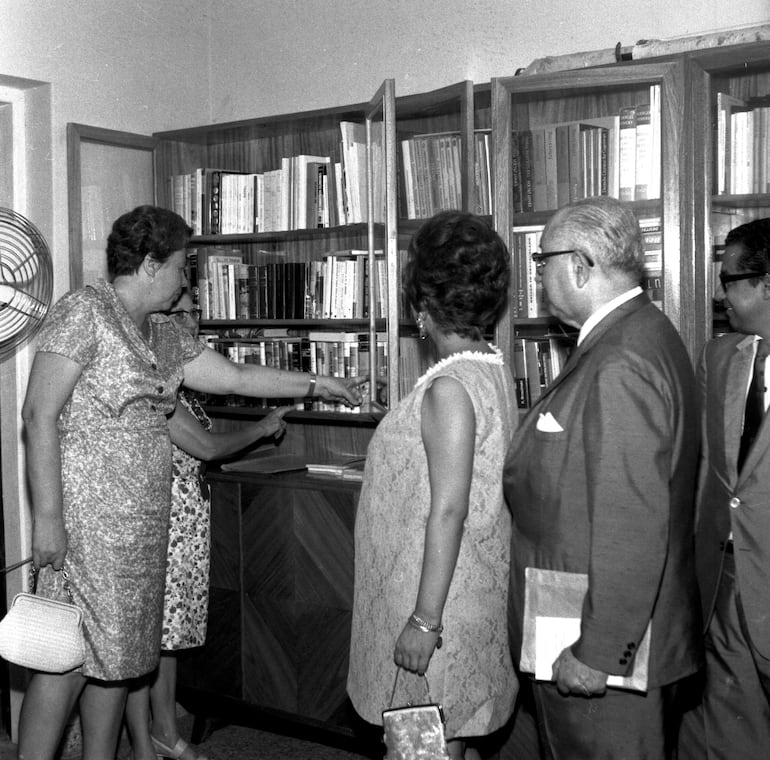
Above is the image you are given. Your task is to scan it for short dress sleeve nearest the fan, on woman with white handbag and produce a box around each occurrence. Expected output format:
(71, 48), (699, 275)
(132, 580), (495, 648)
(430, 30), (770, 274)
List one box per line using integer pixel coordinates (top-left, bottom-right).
(37, 289), (97, 367)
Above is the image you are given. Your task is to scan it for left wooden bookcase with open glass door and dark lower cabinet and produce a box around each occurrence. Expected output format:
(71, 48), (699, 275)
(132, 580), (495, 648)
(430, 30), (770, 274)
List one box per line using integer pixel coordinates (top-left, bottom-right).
(154, 80), (484, 744)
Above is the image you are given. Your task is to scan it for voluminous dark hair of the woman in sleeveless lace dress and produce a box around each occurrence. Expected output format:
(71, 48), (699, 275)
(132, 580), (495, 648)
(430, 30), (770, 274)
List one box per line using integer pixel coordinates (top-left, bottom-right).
(402, 211), (510, 339)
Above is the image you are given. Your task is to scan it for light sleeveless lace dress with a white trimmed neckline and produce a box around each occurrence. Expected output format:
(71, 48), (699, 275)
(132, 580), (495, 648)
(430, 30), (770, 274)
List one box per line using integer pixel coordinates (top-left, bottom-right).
(348, 350), (518, 738)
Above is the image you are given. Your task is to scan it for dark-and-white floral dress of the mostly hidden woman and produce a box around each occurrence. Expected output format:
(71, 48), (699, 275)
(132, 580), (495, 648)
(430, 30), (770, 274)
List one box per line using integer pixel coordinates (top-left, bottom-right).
(161, 391), (211, 650)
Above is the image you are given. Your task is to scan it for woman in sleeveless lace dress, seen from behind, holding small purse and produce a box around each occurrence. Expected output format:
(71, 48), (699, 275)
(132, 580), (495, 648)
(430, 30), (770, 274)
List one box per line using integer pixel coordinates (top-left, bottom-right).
(348, 211), (518, 758)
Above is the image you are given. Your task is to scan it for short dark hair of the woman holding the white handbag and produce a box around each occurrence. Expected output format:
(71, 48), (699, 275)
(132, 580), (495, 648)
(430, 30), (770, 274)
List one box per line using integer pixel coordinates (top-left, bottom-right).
(107, 206), (192, 279)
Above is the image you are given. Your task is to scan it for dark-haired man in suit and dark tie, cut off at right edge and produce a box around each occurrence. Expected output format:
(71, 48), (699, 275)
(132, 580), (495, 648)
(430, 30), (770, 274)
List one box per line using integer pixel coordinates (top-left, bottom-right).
(680, 218), (770, 760)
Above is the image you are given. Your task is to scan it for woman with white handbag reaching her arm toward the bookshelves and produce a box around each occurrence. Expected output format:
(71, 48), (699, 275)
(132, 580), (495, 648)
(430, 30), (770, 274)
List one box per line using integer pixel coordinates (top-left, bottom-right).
(19, 206), (360, 760)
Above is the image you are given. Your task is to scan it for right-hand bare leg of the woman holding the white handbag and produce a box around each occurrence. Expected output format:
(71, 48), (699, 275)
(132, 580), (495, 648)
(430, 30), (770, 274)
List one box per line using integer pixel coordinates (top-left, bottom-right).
(80, 681), (128, 760)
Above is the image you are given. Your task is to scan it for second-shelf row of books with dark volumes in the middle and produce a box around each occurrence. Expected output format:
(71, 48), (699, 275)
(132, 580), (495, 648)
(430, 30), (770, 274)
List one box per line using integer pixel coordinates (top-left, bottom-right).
(188, 246), (396, 319)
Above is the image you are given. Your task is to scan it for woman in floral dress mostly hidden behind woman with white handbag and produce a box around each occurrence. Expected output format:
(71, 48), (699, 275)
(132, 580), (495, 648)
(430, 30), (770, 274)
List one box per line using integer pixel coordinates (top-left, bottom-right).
(126, 291), (293, 760)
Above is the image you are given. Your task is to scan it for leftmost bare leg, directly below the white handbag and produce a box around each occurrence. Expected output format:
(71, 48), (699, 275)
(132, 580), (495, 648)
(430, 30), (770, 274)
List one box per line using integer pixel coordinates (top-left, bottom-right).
(18, 673), (86, 760)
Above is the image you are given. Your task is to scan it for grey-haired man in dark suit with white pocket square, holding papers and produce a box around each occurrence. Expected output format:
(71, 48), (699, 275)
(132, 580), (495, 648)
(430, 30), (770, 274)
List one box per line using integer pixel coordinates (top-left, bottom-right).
(505, 197), (701, 760)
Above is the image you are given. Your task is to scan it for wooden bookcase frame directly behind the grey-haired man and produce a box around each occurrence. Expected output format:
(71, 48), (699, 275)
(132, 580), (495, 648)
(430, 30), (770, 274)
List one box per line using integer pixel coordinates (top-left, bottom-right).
(492, 60), (701, 368)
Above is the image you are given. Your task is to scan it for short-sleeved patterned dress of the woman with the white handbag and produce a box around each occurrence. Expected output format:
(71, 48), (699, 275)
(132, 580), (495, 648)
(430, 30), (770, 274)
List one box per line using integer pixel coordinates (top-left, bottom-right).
(33, 282), (202, 680)
